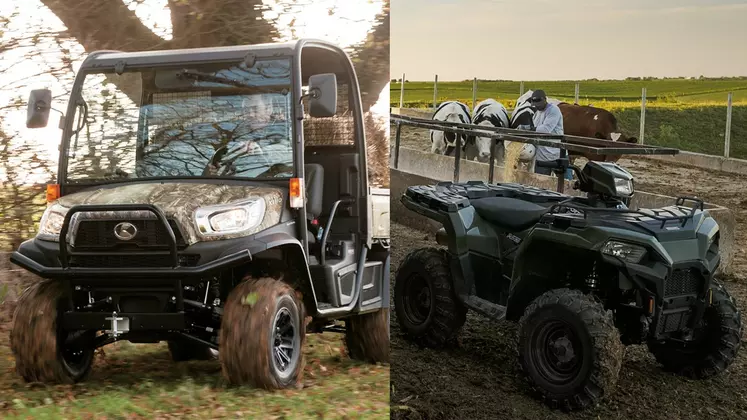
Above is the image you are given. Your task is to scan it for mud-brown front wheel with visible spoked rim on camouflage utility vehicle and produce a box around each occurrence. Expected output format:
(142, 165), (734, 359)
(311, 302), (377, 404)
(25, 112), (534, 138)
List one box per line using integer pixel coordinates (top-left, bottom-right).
(218, 277), (306, 389)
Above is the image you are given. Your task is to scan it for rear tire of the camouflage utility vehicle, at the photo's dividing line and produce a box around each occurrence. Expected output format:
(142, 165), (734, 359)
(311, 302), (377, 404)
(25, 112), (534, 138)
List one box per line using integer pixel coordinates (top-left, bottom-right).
(345, 308), (389, 363)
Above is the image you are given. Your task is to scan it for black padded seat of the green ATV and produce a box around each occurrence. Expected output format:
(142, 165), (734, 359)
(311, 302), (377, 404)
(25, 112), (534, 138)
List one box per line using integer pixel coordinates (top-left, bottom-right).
(471, 197), (549, 232)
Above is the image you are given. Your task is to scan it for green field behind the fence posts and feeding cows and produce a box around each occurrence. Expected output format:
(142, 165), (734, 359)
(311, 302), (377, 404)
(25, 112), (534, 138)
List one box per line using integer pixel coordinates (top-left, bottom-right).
(390, 78), (747, 159)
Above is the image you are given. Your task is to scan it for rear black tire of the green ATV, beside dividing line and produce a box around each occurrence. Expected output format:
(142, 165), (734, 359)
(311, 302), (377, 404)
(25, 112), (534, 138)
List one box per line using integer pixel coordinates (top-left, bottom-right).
(394, 248), (467, 347)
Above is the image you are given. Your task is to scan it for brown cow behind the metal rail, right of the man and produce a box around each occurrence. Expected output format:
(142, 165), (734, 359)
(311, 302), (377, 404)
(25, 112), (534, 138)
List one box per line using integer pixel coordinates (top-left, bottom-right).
(558, 102), (638, 162)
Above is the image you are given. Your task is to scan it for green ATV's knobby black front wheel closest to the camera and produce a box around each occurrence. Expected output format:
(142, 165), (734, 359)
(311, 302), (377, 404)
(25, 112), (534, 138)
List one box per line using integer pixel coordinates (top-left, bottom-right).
(518, 289), (624, 411)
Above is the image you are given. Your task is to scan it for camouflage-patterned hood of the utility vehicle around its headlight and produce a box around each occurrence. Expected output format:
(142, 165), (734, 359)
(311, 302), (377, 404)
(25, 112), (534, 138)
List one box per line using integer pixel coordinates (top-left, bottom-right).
(56, 182), (283, 245)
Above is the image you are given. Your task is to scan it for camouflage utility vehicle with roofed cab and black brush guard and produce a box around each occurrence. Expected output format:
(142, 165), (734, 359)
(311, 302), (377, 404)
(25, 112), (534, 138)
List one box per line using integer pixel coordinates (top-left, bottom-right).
(11, 40), (389, 388)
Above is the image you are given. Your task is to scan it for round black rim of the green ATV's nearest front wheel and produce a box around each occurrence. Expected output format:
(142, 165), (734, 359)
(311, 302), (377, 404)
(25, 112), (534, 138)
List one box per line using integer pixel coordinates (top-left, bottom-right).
(530, 320), (584, 386)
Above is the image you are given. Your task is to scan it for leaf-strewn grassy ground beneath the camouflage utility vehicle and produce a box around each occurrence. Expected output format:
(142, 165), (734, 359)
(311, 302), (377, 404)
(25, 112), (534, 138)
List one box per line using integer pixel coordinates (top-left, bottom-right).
(0, 325), (389, 419)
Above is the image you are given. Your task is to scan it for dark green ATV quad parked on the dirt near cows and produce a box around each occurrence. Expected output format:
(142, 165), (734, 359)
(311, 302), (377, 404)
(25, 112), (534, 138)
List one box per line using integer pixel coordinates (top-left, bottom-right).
(394, 158), (742, 410)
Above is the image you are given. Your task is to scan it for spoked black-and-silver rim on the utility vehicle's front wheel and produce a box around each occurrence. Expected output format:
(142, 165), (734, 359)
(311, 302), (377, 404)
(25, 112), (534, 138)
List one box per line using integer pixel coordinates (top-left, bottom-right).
(272, 307), (300, 379)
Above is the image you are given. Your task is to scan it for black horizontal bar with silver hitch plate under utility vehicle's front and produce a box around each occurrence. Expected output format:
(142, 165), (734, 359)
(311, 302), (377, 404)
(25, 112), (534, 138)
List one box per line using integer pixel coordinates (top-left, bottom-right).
(62, 312), (186, 332)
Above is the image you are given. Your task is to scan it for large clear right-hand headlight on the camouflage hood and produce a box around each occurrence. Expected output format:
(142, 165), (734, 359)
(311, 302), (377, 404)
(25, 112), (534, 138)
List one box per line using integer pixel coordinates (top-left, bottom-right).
(195, 198), (265, 236)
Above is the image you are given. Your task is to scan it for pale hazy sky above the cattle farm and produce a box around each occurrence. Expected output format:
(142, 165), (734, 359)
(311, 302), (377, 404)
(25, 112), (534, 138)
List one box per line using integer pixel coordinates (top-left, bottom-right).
(390, 0), (747, 81)
